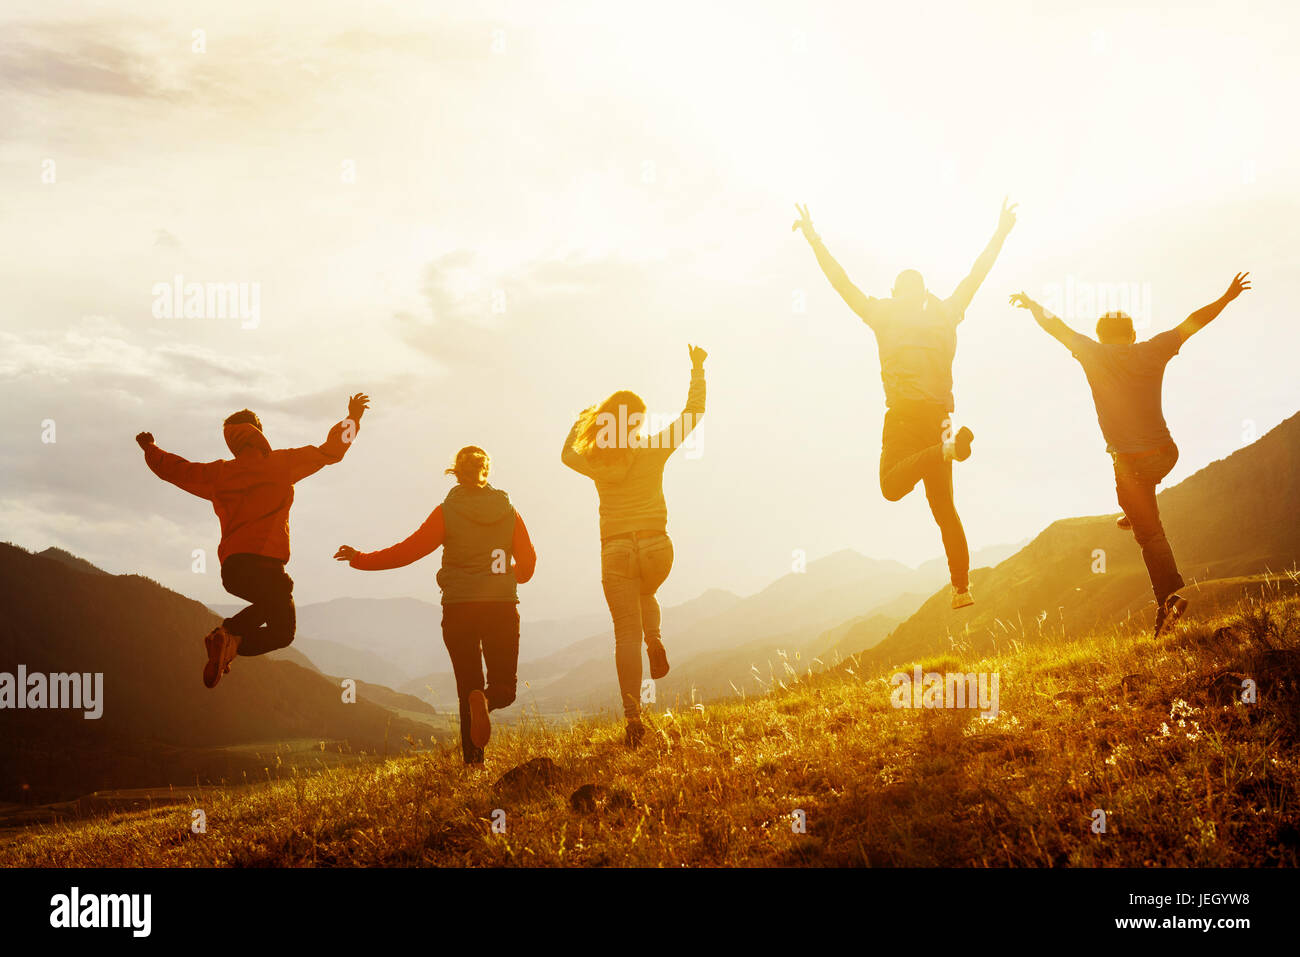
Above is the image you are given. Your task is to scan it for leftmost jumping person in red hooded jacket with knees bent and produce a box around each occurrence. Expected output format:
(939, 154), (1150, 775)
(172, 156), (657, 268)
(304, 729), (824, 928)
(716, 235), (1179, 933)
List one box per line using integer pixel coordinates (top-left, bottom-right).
(135, 393), (369, 688)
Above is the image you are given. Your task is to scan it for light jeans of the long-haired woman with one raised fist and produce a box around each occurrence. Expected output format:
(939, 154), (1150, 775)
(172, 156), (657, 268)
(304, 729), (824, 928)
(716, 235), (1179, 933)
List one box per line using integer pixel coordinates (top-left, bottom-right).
(601, 532), (672, 719)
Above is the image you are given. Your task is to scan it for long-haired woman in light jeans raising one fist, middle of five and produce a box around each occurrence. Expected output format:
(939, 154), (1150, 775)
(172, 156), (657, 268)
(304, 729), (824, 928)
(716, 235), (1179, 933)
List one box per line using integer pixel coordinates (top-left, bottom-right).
(560, 346), (709, 748)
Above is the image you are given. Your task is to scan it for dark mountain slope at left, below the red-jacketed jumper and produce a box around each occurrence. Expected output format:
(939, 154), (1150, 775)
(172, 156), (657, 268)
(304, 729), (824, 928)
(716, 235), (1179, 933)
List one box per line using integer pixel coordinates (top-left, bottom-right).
(0, 544), (441, 802)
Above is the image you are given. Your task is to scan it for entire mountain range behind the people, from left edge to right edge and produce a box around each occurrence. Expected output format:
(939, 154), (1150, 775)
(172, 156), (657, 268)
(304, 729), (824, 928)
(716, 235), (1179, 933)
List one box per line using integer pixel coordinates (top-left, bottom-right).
(0, 415), (1300, 804)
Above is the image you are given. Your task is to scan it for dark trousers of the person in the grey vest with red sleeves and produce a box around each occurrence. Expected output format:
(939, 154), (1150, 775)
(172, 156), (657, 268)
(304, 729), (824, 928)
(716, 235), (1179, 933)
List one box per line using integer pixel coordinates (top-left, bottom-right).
(442, 602), (519, 765)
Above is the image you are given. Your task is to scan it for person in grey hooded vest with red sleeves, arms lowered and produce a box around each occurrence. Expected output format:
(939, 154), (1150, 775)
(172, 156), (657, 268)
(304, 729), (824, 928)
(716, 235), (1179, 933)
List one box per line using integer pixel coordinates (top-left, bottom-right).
(334, 445), (537, 767)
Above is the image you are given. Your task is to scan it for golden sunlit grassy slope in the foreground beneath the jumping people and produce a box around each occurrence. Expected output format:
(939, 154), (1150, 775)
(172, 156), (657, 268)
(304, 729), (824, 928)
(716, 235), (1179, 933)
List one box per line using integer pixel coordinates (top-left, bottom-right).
(0, 585), (1300, 866)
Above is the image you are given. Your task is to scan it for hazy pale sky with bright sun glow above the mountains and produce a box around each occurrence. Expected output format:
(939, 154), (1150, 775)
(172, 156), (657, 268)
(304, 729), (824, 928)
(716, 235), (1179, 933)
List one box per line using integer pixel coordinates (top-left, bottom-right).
(0, 0), (1300, 618)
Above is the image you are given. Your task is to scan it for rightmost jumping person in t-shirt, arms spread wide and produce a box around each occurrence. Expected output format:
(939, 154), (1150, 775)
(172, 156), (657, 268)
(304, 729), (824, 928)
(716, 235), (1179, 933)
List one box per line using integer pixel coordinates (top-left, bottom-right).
(1010, 273), (1251, 637)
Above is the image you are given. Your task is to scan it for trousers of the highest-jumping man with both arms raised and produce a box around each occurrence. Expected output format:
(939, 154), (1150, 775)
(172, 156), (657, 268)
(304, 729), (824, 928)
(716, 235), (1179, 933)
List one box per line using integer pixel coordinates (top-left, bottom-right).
(880, 403), (971, 589)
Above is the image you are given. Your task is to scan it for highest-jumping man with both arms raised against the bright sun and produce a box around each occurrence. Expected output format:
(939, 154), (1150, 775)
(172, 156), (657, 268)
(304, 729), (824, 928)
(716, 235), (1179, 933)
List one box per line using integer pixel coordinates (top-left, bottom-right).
(790, 200), (1015, 609)
